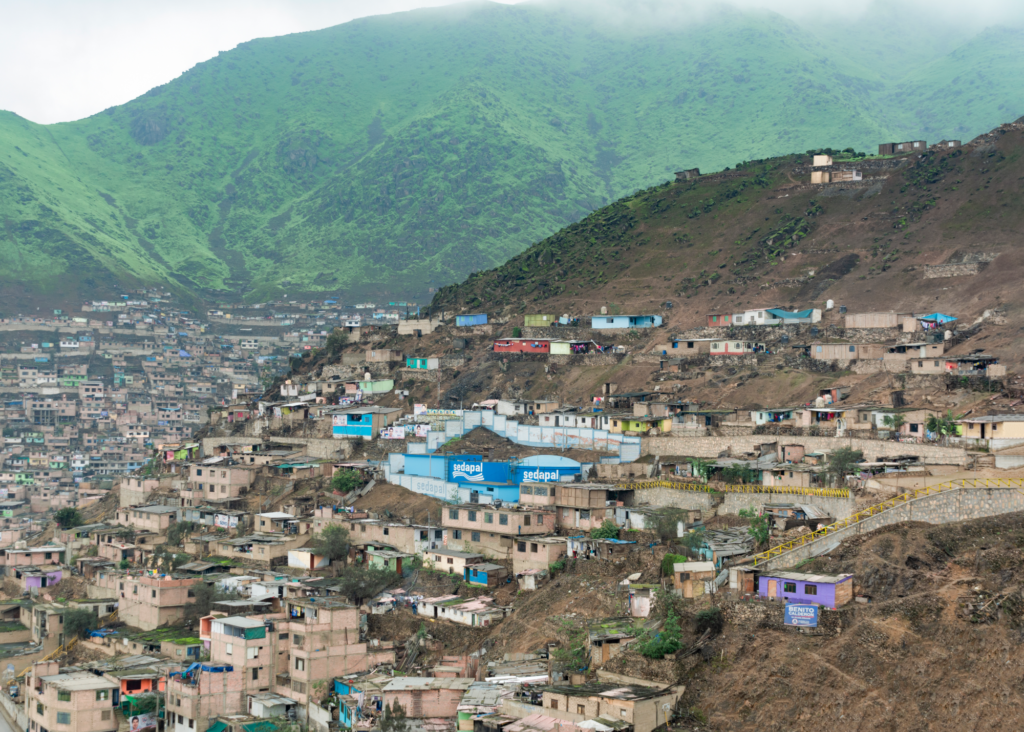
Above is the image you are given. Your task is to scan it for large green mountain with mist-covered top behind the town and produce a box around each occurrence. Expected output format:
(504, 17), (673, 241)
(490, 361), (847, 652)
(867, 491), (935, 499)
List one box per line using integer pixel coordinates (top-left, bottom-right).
(0, 2), (1024, 302)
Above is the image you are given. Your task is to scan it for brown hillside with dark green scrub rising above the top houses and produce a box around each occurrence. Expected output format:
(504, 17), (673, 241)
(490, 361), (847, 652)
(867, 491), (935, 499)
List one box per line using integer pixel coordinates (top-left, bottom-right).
(433, 123), (1024, 350)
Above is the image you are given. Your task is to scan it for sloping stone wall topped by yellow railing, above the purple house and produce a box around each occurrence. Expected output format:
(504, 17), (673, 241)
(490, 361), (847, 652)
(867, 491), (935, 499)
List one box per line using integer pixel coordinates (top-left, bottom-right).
(758, 487), (1024, 569)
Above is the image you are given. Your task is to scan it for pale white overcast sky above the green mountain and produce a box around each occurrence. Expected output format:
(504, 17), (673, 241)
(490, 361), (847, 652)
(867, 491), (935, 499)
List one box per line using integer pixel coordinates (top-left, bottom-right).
(6, 0), (1024, 123)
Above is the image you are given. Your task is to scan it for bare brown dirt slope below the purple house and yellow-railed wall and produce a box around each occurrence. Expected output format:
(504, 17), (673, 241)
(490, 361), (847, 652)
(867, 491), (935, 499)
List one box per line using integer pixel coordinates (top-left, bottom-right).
(685, 514), (1024, 732)
